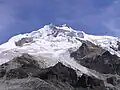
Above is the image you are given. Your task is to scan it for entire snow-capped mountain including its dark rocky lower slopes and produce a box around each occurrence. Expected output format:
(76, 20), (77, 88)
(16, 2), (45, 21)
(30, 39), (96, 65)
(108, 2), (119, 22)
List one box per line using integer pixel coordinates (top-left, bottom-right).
(0, 25), (120, 90)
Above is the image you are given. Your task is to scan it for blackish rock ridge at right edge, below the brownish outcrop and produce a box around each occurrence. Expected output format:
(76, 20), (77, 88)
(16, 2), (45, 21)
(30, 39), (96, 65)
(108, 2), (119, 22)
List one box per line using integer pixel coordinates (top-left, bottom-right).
(71, 47), (120, 75)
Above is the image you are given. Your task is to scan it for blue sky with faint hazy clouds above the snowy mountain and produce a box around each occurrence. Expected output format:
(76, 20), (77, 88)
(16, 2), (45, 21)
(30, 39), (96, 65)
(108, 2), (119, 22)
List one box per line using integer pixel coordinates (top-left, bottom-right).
(0, 0), (120, 43)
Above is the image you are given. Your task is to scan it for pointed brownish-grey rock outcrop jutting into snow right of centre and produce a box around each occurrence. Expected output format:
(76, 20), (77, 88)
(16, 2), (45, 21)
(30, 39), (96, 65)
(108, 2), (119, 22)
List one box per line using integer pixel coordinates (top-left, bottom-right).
(71, 40), (105, 60)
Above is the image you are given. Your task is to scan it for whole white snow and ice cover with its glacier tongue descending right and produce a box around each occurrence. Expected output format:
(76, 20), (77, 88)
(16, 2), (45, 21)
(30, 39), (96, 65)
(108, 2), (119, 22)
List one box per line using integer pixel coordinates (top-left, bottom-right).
(0, 24), (120, 77)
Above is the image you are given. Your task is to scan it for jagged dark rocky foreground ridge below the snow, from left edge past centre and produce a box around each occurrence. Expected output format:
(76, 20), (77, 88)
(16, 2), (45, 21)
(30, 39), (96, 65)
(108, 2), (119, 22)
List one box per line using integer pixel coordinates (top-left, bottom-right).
(0, 54), (106, 90)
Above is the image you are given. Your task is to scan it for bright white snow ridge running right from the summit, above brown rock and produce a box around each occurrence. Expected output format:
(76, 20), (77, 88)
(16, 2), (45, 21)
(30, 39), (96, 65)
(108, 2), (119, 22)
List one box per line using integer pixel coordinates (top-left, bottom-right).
(84, 34), (120, 57)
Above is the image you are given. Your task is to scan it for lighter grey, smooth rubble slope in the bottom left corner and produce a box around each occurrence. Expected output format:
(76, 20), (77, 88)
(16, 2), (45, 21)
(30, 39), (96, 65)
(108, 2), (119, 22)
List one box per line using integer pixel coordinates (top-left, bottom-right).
(0, 77), (58, 90)
